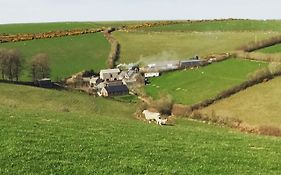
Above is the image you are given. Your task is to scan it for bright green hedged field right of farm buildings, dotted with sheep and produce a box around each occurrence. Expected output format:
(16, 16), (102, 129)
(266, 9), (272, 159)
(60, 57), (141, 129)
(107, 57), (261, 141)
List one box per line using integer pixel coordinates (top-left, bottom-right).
(145, 59), (267, 105)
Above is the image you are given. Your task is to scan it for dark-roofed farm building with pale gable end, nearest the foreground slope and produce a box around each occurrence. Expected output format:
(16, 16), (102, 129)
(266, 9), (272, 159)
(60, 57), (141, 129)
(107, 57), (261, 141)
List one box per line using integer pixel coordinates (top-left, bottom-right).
(100, 84), (129, 97)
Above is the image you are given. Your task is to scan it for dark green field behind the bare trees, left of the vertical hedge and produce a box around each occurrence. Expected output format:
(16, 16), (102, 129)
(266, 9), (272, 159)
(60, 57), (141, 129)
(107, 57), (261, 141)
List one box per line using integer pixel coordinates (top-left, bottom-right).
(0, 33), (110, 80)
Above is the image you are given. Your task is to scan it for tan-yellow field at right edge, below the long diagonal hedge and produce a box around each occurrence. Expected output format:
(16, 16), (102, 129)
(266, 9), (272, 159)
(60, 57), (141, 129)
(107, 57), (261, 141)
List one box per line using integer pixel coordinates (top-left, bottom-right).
(200, 78), (281, 128)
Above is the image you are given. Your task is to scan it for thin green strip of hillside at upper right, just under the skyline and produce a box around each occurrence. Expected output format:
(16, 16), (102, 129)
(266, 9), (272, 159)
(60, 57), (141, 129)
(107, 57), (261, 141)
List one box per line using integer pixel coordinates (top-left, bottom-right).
(143, 20), (281, 32)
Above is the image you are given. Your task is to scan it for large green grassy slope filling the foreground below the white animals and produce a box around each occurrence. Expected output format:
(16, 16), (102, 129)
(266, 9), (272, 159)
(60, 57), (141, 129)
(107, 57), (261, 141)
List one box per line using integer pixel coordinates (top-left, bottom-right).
(0, 84), (281, 174)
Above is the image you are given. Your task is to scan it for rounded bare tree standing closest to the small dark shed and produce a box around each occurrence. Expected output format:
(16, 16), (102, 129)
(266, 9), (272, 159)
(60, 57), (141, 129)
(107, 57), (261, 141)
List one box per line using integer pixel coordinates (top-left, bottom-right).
(31, 53), (50, 81)
